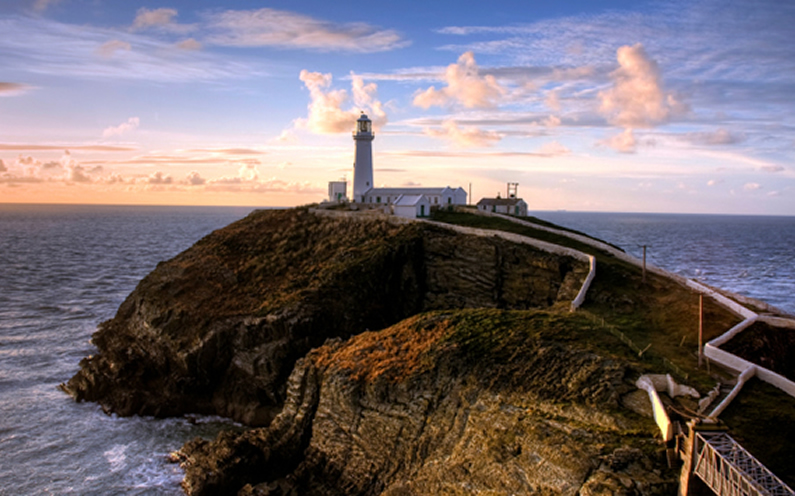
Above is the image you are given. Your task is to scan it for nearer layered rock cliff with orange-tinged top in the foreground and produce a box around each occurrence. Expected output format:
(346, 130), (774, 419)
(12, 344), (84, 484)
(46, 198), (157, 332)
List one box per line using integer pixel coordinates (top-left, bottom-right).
(181, 310), (676, 495)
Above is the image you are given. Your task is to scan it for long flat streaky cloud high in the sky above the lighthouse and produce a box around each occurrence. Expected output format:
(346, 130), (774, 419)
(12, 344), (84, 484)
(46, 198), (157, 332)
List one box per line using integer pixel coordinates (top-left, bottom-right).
(206, 8), (408, 53)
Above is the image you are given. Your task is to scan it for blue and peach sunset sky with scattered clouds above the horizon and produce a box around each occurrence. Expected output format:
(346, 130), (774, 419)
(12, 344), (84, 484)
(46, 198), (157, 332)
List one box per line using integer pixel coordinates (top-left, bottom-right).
(0, 0), (795, 215)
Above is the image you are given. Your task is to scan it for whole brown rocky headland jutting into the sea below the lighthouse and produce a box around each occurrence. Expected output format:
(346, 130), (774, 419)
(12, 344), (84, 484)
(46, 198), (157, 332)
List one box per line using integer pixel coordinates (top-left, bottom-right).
(62, 208), (788, 495)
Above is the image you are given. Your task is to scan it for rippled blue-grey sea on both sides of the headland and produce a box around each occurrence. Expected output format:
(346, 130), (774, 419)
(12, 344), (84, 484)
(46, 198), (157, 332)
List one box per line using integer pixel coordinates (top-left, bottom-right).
(0, 204), (795, 495)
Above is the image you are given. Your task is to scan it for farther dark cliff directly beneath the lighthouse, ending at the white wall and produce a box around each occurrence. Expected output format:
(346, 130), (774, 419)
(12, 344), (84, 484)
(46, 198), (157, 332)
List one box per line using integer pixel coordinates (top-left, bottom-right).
(63, 209), (587, 425)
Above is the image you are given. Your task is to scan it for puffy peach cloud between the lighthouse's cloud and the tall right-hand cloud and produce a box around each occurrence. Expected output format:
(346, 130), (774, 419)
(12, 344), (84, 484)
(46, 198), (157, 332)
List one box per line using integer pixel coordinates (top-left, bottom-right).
(414, 52), (506, 109)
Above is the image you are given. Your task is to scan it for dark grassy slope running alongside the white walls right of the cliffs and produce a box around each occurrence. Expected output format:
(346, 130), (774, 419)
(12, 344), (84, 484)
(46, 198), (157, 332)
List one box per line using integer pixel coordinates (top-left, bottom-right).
(434, 208), (795, 485)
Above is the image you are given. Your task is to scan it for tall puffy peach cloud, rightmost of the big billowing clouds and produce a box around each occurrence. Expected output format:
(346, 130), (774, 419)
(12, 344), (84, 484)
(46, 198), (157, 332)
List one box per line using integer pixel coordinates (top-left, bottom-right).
(599, 43), (687, 129)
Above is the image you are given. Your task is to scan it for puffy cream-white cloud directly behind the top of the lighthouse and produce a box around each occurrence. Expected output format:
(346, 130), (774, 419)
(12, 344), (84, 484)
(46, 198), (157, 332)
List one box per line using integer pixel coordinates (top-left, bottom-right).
(296, 70), (387, 134)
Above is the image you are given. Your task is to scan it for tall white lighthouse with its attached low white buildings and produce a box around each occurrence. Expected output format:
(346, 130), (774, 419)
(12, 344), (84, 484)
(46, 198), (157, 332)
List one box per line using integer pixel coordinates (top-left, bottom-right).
(342, 113), (467, 216)
